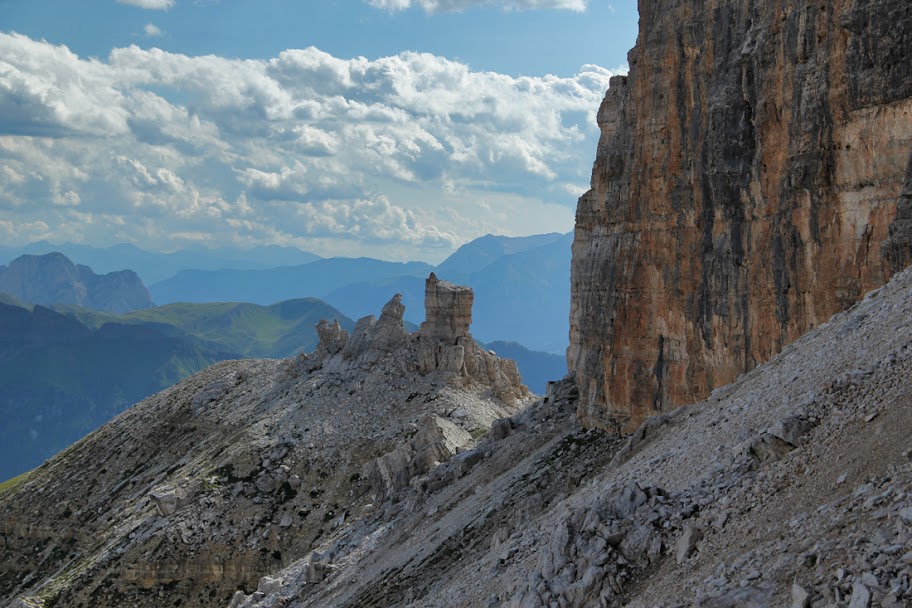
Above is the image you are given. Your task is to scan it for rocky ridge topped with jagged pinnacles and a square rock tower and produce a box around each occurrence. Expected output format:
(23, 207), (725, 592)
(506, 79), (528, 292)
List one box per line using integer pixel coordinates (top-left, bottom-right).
(0, 281), (529, 606)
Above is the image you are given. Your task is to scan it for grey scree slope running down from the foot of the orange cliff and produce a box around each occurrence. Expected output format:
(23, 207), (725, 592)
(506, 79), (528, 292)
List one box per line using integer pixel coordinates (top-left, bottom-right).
(219, 271), (912, 608)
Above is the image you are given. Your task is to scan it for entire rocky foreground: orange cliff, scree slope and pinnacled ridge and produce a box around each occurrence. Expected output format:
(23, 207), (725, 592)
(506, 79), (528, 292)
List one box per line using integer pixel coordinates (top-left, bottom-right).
(0, 0), (912, 608)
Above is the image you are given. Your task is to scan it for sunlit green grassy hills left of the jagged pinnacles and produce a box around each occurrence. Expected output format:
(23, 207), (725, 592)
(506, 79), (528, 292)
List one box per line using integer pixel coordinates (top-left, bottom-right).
(62, 298), (355, 358)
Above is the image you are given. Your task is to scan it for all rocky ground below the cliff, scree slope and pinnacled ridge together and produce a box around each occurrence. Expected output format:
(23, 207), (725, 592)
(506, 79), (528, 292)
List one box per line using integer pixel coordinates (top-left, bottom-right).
(0, 272), (912, 608)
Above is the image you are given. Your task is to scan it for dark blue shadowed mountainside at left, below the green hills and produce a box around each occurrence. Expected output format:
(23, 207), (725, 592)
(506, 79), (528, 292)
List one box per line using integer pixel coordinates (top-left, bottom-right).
(0, 303), (238, 479)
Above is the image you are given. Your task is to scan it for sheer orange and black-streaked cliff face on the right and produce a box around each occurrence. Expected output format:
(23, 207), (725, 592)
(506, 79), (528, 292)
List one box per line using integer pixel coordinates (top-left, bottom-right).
(568, 0), (912, 430)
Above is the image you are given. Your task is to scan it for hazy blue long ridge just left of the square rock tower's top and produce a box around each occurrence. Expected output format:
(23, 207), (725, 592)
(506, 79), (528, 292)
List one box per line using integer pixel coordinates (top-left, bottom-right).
(149, 258), (433, 304)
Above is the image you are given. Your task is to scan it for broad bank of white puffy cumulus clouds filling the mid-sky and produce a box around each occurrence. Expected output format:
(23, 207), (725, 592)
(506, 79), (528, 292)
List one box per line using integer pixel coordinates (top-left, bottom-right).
(0, 34), (612, 258)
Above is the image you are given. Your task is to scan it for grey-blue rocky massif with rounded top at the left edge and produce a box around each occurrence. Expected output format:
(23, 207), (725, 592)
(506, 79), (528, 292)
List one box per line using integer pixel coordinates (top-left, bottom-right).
(0, 253), (152, 312)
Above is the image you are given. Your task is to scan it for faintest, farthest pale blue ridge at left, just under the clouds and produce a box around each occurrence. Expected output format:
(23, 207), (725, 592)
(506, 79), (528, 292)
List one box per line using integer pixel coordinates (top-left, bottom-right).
(0, 241), (322, 285)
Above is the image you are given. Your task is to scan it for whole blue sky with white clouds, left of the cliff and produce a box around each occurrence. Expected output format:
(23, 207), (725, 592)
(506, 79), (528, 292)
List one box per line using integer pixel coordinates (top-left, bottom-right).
(0, 0), (637, 262)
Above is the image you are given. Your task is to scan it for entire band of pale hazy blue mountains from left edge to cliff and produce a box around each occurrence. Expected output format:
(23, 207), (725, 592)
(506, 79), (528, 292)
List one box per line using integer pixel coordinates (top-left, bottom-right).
(0, 233), (573, 355)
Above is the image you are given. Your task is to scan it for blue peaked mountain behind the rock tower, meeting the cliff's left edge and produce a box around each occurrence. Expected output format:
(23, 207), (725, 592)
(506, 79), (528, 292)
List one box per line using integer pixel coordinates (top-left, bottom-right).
(323, 234), (573, 356)
